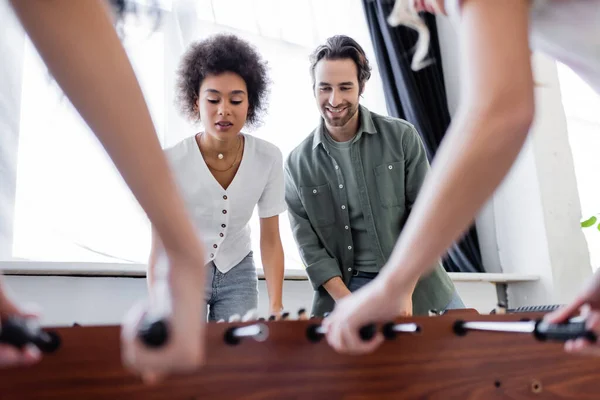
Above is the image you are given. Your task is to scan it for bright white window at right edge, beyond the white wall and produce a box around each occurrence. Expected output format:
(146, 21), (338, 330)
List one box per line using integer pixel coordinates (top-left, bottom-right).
(558, 63), (600, 270)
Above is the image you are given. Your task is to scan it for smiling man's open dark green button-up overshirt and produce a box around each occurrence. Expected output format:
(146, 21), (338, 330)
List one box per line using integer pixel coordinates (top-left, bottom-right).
(285, 106), (455, 316)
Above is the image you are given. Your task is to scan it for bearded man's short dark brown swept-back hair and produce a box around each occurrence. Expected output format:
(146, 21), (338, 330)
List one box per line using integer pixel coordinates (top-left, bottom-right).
(309, 35), (371, 93)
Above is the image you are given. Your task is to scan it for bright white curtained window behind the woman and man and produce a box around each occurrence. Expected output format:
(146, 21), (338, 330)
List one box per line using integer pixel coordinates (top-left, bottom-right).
(0, 0), (386, 269)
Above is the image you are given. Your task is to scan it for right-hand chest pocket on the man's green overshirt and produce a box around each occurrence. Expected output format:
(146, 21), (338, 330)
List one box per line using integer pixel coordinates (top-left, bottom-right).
(375, 162), (405, 208)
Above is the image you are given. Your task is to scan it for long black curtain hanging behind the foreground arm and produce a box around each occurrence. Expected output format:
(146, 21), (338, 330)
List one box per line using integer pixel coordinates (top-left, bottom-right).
(362, 0), (484, 272)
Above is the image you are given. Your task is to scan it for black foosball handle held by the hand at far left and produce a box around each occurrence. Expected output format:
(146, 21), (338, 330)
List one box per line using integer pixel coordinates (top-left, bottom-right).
(0, 317), (61, 353)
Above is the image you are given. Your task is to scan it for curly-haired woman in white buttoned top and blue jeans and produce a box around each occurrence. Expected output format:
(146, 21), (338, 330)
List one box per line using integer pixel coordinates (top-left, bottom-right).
(149, 35), (286, 321)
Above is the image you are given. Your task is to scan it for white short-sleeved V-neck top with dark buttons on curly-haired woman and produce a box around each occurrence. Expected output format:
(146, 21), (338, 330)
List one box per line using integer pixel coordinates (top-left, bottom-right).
(165, 134), (286, 273)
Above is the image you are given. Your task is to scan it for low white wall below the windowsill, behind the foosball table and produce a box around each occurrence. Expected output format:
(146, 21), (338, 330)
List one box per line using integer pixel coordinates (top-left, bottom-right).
(5, 275), (496, 326)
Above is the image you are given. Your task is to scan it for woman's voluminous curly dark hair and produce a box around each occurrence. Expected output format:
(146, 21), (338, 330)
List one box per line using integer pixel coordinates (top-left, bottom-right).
(177, 34), (270, 126)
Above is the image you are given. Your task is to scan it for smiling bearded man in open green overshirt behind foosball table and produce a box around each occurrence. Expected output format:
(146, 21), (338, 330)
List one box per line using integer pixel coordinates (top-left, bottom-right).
(285, 36), (464, 316)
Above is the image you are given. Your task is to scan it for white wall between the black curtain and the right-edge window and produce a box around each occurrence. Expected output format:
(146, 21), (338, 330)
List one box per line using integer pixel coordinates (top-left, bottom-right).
(438, 18), (591, 307)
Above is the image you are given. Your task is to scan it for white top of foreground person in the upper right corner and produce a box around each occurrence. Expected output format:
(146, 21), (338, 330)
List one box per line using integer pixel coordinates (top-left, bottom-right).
(445, 0), (600, 94)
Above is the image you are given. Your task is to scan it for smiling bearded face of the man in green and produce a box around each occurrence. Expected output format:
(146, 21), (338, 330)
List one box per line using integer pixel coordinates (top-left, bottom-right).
(315, 58), (360, 127)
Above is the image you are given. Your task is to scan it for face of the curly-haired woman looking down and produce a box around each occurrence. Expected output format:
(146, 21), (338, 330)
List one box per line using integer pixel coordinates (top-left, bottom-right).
(198, 72), (249, 140)
